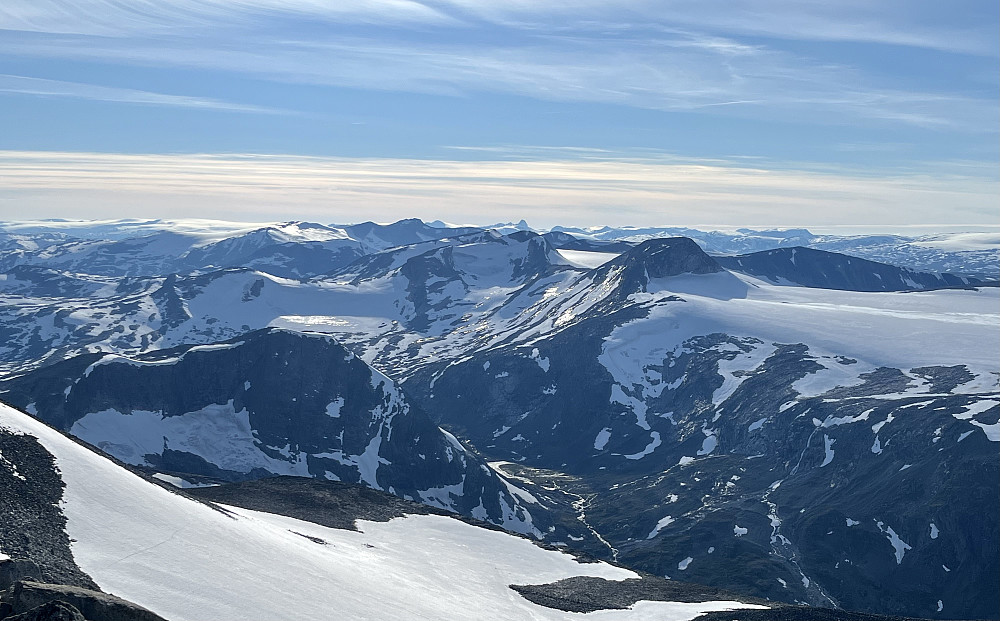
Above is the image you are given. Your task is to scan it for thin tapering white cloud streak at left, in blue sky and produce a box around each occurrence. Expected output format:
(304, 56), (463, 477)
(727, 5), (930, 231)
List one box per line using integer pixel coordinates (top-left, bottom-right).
(0, 74), (291, 114)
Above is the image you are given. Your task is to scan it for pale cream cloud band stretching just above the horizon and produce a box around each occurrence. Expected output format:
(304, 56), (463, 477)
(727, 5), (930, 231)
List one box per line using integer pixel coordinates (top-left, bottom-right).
(0, 151), (998, 230)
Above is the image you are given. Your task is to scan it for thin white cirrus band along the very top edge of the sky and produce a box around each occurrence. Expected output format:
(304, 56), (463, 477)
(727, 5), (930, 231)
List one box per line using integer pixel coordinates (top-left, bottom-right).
(0, 0), (998, 56)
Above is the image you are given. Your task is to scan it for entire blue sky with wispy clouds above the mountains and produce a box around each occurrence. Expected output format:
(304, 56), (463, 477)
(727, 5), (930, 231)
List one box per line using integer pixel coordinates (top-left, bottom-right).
(0, 0), (1000, 231)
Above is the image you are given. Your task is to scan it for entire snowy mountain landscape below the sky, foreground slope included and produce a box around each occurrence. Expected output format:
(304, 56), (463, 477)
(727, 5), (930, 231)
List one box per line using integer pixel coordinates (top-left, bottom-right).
(0, 220), (1000, 621)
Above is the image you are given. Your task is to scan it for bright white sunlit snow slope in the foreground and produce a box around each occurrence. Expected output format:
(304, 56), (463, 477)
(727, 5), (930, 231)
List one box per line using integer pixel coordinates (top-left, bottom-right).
(0, 404), (746, 621)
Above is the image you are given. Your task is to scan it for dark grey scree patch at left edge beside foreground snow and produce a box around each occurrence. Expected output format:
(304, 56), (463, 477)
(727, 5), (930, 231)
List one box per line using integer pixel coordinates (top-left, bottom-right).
(0, 429), (97, 588)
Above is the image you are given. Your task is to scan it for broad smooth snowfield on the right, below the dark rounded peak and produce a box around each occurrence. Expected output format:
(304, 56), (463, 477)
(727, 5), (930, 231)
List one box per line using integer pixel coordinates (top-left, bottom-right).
(600, 272), (1000, 406)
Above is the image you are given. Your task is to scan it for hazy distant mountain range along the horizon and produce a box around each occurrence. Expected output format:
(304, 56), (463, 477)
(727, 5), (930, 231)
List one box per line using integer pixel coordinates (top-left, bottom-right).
(0, 219), (1000, 279)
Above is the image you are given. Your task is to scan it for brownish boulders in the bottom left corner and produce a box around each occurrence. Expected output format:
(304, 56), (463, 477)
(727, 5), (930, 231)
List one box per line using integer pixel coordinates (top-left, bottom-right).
(3, 582), (164, 621)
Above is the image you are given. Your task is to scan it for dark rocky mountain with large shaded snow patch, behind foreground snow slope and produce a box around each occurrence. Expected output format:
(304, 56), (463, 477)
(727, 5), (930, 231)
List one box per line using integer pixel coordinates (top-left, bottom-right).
(0, 330), (546, 532)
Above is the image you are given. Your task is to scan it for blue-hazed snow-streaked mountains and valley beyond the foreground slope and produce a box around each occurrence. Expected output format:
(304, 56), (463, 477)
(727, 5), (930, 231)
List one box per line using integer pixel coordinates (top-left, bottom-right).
(0, 221), (1000, 618)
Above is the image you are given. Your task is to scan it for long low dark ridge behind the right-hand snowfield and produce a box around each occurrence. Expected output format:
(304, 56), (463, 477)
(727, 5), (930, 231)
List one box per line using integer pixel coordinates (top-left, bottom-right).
(715, 247), (986, 291)
